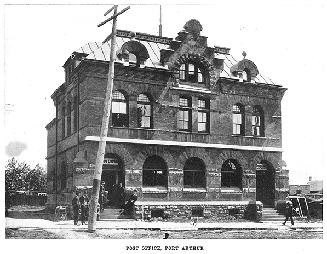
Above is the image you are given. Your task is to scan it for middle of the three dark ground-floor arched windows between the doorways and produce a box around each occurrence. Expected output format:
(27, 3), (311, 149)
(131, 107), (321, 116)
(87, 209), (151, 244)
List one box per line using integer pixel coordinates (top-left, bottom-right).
(183, 157), (206, 188)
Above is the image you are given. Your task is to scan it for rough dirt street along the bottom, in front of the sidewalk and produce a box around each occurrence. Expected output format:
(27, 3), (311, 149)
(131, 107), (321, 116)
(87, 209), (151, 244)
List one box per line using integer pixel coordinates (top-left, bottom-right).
(6, 227), (323, 239)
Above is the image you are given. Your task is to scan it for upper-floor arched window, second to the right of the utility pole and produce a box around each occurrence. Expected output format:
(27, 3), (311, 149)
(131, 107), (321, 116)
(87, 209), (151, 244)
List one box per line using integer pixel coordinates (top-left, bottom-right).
(137, 94), (152, 128)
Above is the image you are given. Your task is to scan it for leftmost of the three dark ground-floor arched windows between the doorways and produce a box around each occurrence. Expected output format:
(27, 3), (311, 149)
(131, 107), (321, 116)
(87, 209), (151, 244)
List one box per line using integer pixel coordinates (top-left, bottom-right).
(143, 155), (168, 187)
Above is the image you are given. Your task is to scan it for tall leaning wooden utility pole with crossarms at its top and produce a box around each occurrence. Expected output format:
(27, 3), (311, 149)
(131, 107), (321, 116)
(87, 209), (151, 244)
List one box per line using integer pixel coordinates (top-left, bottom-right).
(88, 5), (130, 233)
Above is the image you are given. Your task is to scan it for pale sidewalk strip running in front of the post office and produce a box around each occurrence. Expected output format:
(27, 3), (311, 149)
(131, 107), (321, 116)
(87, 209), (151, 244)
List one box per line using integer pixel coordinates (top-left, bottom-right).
(6, 218), (323, 231)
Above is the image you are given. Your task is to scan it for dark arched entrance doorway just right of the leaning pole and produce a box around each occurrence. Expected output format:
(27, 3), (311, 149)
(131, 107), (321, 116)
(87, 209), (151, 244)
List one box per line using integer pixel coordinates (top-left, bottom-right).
(101, 154), (125, 208)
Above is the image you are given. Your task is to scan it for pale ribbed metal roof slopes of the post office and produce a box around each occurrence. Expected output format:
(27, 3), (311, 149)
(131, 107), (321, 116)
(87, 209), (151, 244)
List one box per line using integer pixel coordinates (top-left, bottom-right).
(76, 30), (275, 85)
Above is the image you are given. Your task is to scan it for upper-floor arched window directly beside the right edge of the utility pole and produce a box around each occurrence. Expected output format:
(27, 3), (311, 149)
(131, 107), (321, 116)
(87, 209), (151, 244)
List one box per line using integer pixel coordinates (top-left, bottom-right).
(112, 91), (128, 127)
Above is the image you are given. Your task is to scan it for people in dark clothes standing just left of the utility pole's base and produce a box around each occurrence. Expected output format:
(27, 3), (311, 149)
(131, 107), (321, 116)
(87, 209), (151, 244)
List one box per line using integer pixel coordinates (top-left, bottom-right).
(72, 192), (89, 225)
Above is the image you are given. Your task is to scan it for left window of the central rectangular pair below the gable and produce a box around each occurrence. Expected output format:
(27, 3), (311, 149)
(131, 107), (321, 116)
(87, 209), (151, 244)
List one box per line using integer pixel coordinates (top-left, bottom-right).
(177, 97), (192, 131)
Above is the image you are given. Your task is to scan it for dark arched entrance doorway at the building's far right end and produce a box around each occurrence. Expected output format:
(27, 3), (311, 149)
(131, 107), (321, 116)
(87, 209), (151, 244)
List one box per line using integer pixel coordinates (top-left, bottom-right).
(256, 161), (275, 207)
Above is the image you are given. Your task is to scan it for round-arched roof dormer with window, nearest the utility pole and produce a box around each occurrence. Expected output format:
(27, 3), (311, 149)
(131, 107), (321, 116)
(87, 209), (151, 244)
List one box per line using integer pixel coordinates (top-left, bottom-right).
(117, 40), (149, 66)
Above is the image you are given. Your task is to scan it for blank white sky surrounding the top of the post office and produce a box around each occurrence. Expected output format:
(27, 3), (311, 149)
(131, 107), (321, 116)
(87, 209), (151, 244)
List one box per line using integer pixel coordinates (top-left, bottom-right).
(1, 0), (327, 184)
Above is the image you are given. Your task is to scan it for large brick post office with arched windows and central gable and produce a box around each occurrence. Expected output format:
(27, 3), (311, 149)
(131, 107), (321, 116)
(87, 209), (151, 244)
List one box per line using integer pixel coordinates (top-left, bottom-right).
(46, 20), (288, 218)
